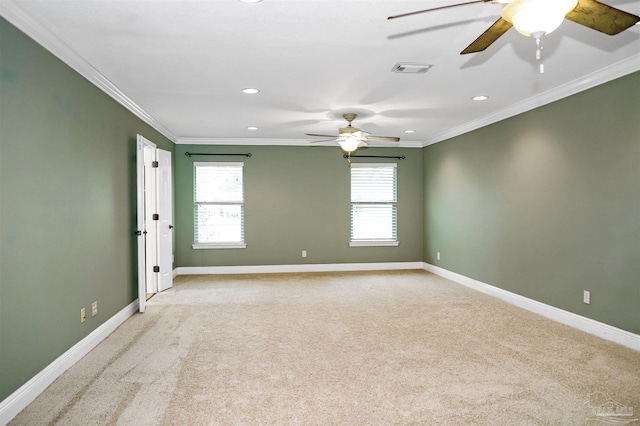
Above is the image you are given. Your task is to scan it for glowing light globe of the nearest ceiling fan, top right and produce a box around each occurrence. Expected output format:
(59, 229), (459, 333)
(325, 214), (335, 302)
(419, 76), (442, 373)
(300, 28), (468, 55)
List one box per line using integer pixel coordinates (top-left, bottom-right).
(502, 0), (578, 37)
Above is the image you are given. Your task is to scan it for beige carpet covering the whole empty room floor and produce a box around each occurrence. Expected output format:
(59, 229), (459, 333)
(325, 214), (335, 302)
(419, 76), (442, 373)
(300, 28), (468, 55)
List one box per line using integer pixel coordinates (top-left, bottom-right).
(12, 271), (640, 425)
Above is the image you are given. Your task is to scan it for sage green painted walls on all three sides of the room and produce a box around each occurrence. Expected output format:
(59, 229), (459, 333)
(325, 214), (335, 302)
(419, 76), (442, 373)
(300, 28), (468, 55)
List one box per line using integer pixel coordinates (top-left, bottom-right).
(0, 10), (640, 412)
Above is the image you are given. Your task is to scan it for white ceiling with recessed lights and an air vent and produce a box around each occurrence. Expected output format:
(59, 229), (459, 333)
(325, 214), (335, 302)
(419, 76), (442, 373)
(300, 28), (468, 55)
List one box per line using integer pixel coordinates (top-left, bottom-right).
(0, 0), (640, 147)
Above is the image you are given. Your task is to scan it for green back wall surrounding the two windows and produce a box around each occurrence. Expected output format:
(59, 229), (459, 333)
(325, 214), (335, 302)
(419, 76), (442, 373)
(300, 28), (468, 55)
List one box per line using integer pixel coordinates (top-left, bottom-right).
(175, 145), (424, 266)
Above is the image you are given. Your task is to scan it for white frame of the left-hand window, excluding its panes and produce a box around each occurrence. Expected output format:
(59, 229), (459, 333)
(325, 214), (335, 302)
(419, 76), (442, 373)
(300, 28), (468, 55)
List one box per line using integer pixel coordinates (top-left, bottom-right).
(191, 161), (247, 250)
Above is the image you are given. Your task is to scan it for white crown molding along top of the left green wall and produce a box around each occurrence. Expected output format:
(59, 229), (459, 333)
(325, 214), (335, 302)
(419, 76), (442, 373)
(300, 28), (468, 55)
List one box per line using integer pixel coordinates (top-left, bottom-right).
(0, 0), (178, 143)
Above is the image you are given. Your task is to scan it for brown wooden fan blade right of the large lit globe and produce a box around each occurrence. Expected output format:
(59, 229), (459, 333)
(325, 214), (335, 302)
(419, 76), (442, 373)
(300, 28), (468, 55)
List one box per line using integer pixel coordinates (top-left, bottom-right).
(566, 0), (640, 35)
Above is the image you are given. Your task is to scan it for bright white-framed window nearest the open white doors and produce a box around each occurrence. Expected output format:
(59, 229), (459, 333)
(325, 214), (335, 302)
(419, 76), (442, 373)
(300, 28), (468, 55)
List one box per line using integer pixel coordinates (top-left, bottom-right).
(193, 163), (246, 249)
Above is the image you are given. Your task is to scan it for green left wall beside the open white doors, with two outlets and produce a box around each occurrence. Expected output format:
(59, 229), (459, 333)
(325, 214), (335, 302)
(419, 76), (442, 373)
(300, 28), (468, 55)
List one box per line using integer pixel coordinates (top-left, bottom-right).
(0, 18), (174, 400)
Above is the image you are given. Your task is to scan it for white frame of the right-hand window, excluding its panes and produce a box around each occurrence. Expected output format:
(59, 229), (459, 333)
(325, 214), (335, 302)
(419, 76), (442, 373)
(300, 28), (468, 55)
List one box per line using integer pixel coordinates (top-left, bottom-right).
(349, 163), (400, 247)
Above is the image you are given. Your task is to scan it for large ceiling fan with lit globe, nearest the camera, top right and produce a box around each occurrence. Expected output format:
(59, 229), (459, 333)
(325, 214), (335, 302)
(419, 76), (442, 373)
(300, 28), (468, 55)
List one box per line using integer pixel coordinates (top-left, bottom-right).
(387, 0), (640, 72)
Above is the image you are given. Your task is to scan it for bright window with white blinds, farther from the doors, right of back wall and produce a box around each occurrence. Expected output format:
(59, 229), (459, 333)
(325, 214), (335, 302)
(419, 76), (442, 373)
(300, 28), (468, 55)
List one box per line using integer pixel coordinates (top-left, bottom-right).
(349, 163), (398, 247)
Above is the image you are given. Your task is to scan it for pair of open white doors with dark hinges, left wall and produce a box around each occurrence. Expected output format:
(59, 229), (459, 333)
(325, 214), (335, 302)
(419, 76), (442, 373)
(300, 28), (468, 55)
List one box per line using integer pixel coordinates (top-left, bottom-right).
(136, 135), (173, 312)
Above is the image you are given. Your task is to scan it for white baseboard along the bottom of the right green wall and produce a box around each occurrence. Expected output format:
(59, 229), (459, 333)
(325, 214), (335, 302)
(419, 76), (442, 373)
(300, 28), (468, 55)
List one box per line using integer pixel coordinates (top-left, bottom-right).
(423, 263), (640, 351)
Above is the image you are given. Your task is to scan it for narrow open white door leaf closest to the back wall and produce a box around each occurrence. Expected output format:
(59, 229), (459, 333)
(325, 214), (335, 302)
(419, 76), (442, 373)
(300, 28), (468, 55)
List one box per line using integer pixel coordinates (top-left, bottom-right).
(156, 149), (173, 291)
